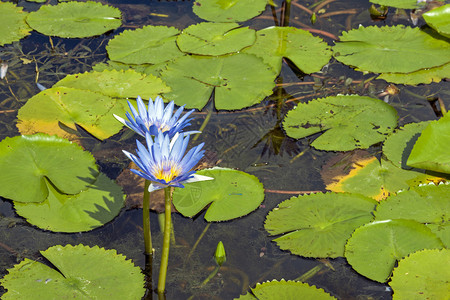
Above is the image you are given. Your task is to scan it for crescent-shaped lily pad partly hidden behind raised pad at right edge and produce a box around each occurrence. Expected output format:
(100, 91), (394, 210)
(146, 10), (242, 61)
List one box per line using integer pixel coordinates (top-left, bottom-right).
(383, 122), (429, 169)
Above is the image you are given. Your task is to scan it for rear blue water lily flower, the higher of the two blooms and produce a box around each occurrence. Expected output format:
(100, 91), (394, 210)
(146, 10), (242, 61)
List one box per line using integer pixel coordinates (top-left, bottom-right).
(114, 96), (200, 138)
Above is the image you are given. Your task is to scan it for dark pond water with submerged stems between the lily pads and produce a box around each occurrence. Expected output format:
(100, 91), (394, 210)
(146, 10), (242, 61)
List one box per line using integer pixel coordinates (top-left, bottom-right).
(0, 1), (449, 299)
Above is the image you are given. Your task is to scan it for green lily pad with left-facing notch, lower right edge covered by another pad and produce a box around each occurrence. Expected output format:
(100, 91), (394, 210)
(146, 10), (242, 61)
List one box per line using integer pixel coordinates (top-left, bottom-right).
(264, 193), (376, 258)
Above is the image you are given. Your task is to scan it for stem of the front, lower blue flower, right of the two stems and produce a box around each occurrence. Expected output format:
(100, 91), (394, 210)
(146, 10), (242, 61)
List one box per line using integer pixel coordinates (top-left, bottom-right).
(158, 187), (172, 294)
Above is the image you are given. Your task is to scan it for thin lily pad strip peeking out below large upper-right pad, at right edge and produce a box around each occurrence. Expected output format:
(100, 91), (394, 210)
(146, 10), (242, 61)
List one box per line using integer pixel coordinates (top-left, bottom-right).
(378, 63), (450, 85)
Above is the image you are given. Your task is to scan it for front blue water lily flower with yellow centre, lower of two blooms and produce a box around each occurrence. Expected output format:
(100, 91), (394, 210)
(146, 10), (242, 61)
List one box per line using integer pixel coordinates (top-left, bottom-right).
(122, 132), (214, 192)
